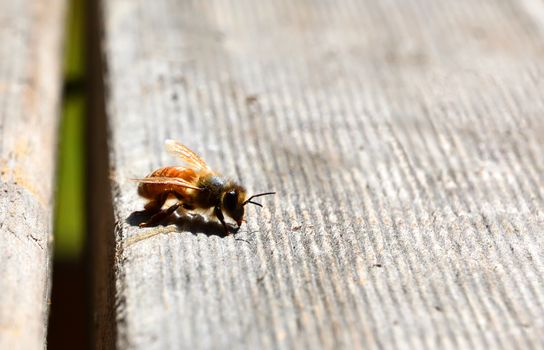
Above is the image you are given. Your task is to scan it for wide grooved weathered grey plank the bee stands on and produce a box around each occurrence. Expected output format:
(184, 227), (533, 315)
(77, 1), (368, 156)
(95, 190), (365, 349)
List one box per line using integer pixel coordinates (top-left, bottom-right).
(102, 0), (544, 349)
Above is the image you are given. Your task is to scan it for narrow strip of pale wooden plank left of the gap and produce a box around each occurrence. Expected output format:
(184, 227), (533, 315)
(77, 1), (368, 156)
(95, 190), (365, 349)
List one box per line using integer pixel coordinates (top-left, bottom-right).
(0, 0), (65, 349)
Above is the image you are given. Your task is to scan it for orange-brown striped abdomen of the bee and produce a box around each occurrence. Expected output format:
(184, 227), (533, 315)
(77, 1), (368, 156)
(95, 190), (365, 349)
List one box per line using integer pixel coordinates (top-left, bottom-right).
(138, 167), (198, 199)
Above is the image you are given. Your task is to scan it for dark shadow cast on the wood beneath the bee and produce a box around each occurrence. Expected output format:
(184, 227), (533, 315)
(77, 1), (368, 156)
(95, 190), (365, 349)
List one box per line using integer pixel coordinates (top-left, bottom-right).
(126, 211), (236, 237)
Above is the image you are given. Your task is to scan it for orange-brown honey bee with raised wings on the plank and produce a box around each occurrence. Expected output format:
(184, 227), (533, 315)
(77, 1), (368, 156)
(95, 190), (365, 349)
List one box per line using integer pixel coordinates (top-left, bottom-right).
(133, 140), (275, 235)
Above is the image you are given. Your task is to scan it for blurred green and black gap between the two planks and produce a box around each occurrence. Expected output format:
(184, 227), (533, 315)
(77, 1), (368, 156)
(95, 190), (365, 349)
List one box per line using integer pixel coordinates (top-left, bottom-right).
(47, 0), (89, 349)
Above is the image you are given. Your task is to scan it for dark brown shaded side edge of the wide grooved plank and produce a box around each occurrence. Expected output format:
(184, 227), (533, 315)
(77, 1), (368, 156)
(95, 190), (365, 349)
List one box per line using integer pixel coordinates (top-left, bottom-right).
(85, 0), (117, 349)
